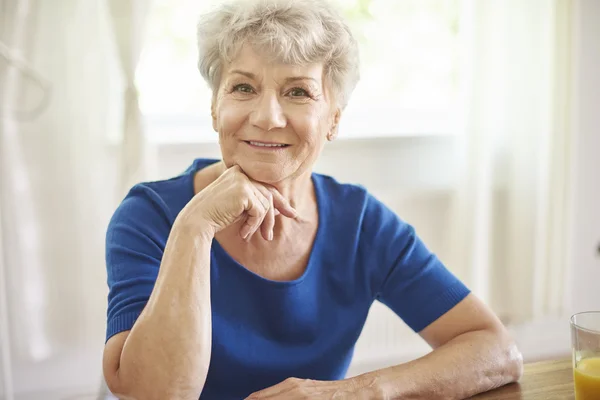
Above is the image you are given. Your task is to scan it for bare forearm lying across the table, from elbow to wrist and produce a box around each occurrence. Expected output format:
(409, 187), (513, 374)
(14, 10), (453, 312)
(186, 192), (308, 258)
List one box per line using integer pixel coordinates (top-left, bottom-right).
(357, 331), (522, 400)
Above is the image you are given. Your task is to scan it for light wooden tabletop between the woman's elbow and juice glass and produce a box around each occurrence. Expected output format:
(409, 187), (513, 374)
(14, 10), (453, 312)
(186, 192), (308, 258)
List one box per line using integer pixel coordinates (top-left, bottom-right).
(472, 359), (575, 400)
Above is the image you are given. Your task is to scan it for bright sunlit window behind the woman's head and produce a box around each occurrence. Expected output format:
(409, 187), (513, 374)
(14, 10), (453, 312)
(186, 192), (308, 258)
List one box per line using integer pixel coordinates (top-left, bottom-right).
(138, 0), (460, 142)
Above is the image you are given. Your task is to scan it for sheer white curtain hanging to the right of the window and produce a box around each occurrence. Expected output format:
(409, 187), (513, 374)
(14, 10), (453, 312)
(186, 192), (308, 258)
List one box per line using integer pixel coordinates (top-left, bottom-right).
(448, 0), (573, 322)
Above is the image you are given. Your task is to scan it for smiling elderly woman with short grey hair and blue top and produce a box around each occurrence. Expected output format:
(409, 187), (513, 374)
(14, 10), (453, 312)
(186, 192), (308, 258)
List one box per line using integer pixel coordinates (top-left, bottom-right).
(103, 0), (522, 400)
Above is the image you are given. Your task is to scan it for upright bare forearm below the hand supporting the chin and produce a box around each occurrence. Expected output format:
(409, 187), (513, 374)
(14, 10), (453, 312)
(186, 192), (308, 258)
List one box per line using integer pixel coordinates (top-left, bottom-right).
(118, 227), (212, 399)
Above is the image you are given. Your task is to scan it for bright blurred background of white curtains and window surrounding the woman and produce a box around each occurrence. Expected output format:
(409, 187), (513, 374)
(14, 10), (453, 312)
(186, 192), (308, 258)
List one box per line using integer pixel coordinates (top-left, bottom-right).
(0, 0), (600, 400)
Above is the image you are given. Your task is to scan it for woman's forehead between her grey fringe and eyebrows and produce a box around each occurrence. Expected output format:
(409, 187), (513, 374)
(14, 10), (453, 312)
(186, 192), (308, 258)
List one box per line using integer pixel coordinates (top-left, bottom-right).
(224, 45), (323, 82)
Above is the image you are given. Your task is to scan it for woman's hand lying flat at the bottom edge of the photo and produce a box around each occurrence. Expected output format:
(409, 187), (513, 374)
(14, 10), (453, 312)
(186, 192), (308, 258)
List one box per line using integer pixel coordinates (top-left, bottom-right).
(246, 378), (375, 400)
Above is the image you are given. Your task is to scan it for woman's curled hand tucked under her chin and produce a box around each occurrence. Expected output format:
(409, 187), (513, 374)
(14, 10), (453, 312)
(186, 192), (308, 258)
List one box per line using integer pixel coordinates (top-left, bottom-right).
(178, 165), (297, 240)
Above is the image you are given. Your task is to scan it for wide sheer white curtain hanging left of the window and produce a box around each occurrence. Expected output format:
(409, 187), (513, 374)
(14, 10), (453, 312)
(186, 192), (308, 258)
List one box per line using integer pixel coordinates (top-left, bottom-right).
(0, 0), (148, 399)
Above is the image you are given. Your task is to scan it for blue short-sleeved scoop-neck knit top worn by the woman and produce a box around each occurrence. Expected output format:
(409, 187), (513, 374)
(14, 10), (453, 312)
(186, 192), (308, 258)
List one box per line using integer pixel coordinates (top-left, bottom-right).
(106, 159), (469, 400)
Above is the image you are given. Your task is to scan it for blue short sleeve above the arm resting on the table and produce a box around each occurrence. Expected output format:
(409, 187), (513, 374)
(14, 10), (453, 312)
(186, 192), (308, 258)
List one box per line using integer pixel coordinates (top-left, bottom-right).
(363, 195), (470, 332)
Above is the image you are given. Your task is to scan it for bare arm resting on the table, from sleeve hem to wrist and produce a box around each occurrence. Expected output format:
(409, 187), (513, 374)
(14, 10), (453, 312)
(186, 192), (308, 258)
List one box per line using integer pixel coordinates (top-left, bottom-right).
(352, 295), (523, 400)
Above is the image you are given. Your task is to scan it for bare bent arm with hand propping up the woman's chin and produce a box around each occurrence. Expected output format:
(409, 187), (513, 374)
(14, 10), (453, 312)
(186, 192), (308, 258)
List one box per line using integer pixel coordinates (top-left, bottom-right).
(103, 167), (296, 400)
